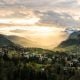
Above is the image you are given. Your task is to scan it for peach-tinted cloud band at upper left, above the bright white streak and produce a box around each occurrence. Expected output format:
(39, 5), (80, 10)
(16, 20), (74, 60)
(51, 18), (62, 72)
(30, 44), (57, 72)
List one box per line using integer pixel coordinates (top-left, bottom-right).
(0, 8), (36, 18)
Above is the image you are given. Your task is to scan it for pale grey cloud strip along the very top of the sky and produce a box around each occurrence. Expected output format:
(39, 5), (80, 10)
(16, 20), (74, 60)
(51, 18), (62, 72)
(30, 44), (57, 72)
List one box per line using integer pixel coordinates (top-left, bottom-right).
(0, 0), (80, 9)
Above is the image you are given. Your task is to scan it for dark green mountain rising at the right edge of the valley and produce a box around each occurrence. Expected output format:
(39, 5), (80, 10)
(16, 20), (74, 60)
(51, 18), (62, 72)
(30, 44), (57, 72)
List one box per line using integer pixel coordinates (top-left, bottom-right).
(55, 31), (80, 52)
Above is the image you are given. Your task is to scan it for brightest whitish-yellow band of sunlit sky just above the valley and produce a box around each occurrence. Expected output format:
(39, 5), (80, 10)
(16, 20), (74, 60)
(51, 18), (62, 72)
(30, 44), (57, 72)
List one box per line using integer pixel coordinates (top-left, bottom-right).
(0, 25), (63, 36)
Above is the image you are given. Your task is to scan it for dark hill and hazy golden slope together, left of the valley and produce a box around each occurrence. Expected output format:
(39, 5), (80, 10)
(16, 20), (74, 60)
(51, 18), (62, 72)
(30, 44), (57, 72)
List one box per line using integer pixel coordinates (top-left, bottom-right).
(0, 34), (43, 48)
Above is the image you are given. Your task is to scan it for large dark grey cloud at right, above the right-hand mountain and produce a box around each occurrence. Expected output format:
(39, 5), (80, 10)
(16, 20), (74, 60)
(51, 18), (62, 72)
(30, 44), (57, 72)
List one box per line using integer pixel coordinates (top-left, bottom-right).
(36, 11), (80, 27)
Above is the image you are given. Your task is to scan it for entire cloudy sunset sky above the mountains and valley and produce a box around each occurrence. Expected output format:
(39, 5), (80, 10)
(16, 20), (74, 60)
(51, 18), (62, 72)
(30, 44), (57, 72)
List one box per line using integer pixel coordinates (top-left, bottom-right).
(0, 0), (80, 46)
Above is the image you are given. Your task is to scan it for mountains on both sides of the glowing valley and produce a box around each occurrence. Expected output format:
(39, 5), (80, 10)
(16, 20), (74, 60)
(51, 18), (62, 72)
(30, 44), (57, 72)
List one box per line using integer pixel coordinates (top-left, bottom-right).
(0, 31), (80, 53)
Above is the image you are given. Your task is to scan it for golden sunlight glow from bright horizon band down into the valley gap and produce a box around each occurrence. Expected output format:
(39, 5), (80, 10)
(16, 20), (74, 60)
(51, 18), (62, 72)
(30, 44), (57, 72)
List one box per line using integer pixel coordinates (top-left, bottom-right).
(0, 25), (66, 49)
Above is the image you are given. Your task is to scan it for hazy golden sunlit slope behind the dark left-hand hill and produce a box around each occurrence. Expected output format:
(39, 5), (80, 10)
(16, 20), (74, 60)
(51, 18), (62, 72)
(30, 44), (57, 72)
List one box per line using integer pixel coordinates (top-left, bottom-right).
(6, 35), (38, 47)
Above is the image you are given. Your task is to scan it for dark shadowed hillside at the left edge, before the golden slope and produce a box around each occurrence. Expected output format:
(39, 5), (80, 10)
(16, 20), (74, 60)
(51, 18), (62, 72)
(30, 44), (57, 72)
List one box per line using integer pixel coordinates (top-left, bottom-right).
(0, 34), (14, 46)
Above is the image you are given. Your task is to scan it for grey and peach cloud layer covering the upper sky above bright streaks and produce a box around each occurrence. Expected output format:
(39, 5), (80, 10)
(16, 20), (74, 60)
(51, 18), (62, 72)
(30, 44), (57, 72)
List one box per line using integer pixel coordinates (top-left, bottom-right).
(0, 0), (80, 27)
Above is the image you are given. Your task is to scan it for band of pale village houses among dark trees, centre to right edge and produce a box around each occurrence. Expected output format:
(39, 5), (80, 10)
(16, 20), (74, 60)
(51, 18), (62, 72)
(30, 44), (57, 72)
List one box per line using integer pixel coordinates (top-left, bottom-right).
(19, 52), (80, 67)
